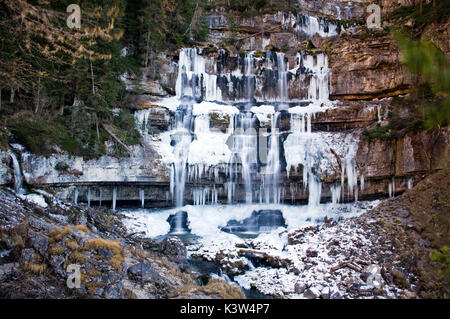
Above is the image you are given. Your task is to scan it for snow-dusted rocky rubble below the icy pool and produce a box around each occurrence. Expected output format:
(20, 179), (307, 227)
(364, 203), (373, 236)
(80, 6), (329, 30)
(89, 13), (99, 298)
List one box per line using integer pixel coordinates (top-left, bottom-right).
(188, 209), (416, 299)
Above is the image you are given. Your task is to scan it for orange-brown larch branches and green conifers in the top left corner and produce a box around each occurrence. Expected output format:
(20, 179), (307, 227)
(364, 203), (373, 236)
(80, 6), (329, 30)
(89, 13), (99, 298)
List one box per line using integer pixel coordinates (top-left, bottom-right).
(0, 0), (144, 157)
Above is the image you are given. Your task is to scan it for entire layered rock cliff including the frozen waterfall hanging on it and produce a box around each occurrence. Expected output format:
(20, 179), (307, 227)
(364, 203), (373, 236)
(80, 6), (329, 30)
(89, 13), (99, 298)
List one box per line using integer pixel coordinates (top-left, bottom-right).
(0, 0), (449, 207)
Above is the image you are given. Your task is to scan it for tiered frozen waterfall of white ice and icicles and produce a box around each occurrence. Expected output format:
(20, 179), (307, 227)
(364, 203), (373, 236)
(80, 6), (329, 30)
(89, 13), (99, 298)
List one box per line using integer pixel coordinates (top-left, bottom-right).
(136, 47), (362, 208)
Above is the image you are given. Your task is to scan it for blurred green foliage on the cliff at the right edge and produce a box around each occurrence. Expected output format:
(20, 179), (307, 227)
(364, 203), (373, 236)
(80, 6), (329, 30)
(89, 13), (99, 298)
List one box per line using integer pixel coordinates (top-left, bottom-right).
(363, 33), (450, 140)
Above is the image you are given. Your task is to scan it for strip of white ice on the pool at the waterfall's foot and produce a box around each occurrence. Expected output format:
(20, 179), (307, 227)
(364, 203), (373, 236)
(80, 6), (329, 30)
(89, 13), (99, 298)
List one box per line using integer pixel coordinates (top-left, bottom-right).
(120, 201), (379, 241)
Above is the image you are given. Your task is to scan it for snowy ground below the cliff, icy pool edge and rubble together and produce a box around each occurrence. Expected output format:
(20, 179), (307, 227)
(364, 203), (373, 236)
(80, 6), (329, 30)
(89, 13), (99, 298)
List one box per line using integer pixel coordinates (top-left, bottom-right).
(122, 201), (418, 298)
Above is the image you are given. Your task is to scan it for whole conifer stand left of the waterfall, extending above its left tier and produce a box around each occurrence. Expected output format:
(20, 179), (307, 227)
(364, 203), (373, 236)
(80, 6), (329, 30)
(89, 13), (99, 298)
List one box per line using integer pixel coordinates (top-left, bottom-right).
(0, 0), (209, 157)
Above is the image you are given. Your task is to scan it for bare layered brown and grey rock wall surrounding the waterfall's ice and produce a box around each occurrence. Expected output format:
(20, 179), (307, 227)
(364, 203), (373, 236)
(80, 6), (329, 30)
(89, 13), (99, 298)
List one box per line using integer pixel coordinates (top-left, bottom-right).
(0, 0), (450, 206)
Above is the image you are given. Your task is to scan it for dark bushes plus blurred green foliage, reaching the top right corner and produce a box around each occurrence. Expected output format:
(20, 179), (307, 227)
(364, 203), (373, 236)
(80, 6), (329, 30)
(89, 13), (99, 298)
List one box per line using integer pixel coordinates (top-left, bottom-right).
(365, 1), (450, 139)
